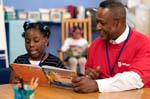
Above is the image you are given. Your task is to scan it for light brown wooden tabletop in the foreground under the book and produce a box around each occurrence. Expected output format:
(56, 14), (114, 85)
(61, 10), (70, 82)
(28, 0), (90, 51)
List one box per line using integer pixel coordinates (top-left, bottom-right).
(0, 84), (150, 99)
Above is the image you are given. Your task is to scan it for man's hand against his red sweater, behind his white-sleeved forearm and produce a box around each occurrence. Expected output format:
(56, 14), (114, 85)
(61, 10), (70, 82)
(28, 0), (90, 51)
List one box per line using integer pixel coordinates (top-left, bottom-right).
(85, 66), (100, 80)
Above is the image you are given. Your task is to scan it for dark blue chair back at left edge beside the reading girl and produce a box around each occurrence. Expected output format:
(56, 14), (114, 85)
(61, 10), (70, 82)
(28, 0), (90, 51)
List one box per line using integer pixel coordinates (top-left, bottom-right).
(0, 68), (11, 84)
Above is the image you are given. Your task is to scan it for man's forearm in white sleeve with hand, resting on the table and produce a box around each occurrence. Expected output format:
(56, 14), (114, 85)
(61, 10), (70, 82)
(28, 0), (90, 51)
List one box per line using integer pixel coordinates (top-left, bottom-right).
(72, 72), (144, 93)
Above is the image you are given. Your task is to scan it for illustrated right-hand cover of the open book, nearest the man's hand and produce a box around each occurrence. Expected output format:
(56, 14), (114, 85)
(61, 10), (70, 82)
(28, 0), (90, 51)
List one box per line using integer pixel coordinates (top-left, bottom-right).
(42, 66), (77, 88)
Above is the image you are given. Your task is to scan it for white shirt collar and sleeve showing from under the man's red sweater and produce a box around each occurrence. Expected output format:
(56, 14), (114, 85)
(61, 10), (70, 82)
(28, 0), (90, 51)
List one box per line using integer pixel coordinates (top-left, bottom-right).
(96, 25), (144, 92)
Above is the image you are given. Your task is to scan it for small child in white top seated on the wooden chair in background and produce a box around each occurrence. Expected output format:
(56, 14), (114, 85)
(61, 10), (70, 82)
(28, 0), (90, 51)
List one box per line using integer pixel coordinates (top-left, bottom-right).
(61, 26), (88, 74)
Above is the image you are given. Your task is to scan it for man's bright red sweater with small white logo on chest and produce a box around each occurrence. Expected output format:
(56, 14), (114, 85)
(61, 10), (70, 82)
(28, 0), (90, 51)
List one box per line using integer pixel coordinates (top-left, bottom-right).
(86, 30), (150, 87)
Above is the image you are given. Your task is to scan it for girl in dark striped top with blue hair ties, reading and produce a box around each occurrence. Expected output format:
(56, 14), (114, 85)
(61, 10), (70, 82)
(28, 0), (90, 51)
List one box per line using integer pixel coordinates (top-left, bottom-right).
(11, 21), (65, 83)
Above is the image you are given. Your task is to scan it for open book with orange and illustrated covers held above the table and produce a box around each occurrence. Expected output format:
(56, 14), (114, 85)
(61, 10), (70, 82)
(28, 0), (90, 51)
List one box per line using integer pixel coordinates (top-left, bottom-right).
(11, 63), (76, 87)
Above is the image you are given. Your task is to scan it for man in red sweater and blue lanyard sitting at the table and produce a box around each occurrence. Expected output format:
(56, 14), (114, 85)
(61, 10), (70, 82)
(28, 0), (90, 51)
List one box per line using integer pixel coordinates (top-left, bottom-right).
(72, 1), (150, 93)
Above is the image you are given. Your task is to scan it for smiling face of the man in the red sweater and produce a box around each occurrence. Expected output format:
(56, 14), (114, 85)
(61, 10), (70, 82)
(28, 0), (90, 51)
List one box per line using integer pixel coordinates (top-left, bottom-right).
(96, 8), (117, 41)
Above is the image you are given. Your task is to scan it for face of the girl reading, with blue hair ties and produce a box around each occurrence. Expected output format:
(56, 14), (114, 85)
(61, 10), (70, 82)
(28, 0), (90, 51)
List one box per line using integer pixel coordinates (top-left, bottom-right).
(25, 28), (48, 60)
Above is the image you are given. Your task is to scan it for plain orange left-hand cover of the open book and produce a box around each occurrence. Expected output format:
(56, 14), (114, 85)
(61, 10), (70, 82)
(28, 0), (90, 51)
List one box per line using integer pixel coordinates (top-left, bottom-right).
(11, 63), (48, 85)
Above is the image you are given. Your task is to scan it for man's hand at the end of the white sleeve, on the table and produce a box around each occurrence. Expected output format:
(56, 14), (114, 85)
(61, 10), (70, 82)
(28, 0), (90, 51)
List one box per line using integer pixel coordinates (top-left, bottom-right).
(72, 76), (98, 93)
